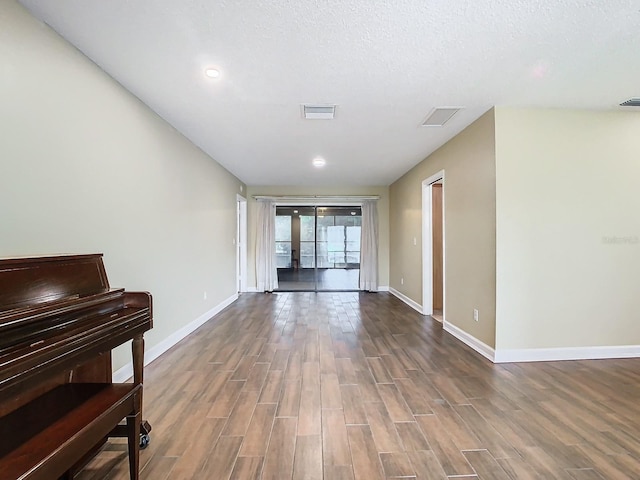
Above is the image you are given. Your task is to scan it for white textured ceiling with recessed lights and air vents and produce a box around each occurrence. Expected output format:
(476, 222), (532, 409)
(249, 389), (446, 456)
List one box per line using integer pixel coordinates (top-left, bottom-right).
(21, 0), (640, 186)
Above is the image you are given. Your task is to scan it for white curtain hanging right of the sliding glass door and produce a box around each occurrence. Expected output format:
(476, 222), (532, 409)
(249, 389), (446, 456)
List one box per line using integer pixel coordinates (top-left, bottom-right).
(360, 200), (378, 292)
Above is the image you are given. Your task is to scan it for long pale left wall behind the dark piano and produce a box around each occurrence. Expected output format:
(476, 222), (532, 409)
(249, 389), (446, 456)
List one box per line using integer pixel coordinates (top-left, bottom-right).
(0, 0), (245, 368)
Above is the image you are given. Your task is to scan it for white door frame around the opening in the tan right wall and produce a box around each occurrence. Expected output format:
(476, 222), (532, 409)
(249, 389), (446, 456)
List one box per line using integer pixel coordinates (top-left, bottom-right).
(422, 170), (447, 322)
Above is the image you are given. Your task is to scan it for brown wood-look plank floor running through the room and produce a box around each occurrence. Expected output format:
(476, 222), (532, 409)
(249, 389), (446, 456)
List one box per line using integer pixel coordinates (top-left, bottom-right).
(79, 293), (640, 480)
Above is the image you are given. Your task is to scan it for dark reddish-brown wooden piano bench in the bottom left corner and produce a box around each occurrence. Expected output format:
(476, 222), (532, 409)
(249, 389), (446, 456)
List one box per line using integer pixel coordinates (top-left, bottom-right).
(0, 383), (142, 480)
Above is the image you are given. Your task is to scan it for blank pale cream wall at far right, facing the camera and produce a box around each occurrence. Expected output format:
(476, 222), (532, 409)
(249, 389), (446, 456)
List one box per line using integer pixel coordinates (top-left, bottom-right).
(496, 108), (640, 349)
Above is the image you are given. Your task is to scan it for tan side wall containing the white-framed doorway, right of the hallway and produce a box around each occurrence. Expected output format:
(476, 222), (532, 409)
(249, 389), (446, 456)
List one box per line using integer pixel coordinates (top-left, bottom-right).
(389, 110), (496, 347)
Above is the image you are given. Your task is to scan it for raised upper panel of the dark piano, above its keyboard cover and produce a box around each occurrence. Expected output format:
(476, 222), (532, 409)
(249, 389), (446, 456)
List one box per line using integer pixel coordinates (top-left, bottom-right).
(0, 253), (109, 311)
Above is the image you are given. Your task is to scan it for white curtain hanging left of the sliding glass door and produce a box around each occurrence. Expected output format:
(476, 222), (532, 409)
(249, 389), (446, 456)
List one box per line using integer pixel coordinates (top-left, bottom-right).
(256, 199), (278, 292)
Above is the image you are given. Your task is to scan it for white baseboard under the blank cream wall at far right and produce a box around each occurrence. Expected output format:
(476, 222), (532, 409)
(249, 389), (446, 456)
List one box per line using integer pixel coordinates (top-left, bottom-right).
(494, 345), (640, 363)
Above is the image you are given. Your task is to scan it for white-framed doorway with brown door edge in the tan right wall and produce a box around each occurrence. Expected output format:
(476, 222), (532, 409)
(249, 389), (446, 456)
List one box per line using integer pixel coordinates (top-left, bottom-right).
(422, 170), (446, 322)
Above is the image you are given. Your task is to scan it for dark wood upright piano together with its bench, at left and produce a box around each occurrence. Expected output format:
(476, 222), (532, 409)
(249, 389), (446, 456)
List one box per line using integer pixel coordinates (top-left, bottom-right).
(0, 254), (153, 480)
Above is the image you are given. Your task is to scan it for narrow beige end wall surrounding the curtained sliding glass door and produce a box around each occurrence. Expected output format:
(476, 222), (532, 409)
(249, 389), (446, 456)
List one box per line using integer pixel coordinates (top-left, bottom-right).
(247, 186), (389, 289)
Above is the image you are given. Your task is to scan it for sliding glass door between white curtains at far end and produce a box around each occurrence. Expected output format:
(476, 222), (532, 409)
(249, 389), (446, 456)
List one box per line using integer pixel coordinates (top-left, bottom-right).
(276, 206), (362, 291)
